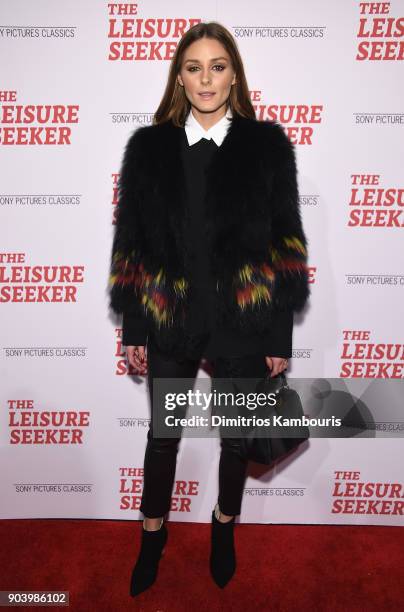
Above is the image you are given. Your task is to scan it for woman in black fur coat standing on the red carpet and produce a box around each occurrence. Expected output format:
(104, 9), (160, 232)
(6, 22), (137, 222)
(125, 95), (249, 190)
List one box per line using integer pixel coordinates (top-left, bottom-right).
(109, 22), (309, 596)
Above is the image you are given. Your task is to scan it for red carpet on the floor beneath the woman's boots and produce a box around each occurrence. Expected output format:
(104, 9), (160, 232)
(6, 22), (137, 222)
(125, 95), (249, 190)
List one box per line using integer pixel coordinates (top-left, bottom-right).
(0, 519), (404, 612)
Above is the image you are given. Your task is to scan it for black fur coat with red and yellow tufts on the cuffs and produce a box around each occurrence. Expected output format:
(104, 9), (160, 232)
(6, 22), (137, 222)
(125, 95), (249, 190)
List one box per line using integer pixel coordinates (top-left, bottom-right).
(108, 115), (310, 350)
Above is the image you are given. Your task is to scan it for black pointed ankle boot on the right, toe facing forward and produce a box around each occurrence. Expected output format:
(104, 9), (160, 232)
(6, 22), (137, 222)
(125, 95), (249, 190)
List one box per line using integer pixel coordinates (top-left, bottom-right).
(209, 502), (236, 588)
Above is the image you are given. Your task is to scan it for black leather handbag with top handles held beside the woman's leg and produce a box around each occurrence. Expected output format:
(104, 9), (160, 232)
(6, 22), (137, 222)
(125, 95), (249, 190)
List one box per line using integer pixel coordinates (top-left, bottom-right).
(240, 372), (310, 465)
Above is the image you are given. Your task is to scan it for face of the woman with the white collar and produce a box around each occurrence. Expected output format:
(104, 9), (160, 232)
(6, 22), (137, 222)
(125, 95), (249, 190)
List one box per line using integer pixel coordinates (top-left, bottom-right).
(177, 38), (236, 113)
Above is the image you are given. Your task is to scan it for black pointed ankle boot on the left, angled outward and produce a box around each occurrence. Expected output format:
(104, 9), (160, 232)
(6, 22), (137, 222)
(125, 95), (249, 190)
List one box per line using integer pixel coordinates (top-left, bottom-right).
(130, 522), (168, 597)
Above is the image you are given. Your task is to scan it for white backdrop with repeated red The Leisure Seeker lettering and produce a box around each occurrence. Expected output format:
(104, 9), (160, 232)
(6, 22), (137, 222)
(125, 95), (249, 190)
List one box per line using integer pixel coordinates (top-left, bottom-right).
(0, 0), (404, 525)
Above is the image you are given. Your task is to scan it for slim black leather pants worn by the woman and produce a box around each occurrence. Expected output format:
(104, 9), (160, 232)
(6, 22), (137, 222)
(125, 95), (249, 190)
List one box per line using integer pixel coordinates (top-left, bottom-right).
(140, 343), (268, 518)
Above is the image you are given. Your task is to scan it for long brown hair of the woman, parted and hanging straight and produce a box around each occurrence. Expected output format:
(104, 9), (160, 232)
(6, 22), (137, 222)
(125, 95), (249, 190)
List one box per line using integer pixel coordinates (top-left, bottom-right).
(153, 21), (256, 127)
